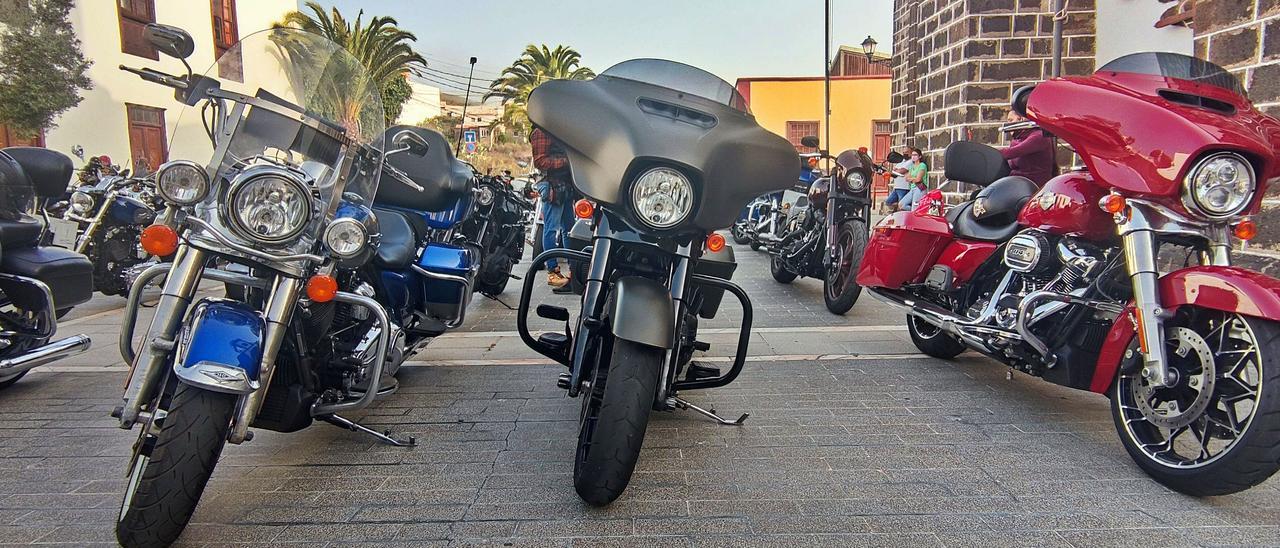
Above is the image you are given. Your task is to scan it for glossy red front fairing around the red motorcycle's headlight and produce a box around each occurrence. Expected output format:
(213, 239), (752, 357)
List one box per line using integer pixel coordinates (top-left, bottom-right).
(1028, 72), (1280, 209)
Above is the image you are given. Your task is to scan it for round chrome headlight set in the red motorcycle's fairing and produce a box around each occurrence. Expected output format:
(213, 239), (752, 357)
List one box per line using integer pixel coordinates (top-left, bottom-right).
(1183, 152), (1257, 220)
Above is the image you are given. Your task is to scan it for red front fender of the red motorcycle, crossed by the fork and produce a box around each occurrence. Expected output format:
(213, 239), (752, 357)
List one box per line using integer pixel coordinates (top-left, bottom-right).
(1089, 266), (1280, 393)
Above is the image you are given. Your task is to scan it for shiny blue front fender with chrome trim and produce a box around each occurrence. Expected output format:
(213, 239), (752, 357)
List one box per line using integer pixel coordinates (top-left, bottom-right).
(173, 298), (264, 394)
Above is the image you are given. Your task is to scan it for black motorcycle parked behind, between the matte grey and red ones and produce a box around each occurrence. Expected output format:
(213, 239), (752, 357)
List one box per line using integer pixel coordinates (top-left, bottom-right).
(768, 136), (902, 315)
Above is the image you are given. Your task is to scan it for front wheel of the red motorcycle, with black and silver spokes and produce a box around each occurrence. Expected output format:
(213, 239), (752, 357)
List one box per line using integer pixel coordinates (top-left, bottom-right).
(1111, 307), (1280, 497)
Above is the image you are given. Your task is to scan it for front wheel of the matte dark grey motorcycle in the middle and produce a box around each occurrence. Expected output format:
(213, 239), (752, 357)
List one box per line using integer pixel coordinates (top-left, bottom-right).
(573, 339), (664, 506)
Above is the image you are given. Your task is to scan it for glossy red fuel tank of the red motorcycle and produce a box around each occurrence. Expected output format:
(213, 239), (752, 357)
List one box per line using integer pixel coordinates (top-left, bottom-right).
(1018, 172), (1116, 241)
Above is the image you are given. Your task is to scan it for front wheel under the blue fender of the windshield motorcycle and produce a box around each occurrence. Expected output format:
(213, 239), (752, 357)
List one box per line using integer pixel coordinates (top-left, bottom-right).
(115, 384), (238, 547)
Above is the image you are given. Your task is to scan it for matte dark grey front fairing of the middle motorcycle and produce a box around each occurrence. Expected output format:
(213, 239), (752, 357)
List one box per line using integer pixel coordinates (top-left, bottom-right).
(529, 76), (796, 230)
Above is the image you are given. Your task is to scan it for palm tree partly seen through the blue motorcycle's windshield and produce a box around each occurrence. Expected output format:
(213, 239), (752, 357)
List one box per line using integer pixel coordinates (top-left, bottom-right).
(275, 1), (426, 124)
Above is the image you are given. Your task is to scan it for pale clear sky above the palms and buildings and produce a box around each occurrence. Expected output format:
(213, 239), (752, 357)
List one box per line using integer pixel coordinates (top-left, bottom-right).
(320, 0), (893, 98)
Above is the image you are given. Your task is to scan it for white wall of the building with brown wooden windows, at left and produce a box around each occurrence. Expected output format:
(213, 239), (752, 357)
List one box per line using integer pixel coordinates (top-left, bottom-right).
(45, 0), (297, 171)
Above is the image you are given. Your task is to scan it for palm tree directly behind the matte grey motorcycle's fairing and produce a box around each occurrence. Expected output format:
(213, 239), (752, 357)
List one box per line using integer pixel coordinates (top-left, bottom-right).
(484, 44), (595, 131)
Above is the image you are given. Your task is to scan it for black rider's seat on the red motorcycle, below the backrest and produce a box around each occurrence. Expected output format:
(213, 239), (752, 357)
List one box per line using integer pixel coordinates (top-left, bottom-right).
(947, 177), (1039, 242)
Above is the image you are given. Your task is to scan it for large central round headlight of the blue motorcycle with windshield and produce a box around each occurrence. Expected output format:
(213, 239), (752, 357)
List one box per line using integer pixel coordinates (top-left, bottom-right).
(228, 174), (311, 243)
